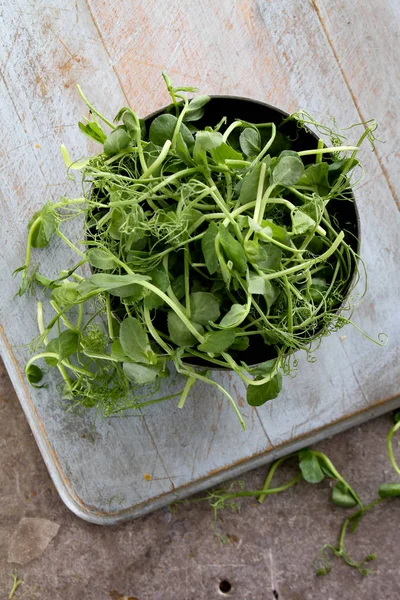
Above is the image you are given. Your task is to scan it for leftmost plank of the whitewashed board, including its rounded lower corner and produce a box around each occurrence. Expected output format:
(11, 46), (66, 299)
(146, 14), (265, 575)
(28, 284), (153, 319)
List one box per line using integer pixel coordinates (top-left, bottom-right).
(0, 2), (176, 509)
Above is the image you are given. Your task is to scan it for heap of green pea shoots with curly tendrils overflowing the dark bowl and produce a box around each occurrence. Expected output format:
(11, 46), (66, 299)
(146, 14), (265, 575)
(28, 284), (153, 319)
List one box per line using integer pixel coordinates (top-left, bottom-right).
(18, 75), (375, 426)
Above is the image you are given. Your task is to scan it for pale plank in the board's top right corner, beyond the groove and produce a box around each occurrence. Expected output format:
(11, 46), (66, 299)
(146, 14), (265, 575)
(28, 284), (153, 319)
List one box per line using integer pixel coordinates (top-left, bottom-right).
(313, 0), (400, 207)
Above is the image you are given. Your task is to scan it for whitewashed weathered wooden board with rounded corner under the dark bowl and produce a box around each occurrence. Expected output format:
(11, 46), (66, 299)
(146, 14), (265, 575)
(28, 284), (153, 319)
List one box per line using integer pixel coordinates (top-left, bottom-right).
(0, 0), (400, 523)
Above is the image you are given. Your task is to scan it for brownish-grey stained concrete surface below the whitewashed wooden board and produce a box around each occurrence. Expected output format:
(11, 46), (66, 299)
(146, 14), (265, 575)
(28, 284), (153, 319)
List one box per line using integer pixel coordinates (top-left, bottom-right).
(0, 356), (400, 600)
